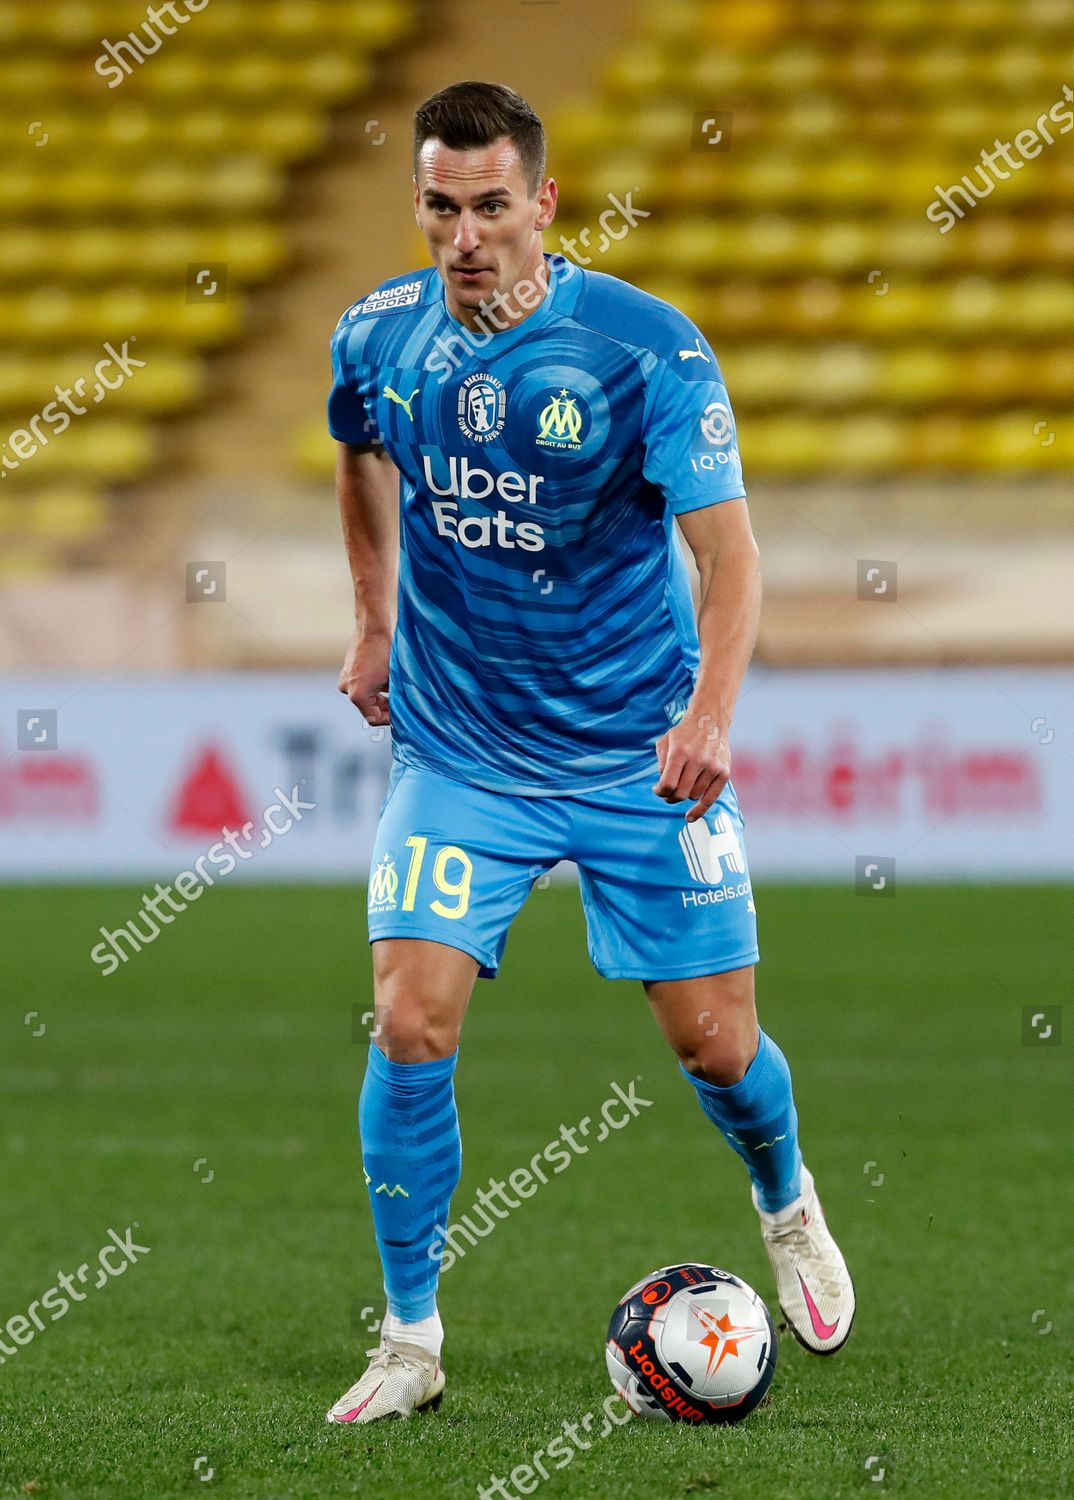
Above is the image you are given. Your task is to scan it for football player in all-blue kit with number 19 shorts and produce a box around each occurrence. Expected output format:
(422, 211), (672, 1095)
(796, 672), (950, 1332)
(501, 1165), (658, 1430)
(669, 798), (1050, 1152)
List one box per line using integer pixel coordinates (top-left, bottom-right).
(327, 83), (855, 1422)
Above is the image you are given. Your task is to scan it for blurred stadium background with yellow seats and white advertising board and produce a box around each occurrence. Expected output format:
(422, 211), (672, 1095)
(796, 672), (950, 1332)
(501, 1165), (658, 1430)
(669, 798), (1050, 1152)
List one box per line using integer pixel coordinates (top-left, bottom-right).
(0, 0), (1074, 876)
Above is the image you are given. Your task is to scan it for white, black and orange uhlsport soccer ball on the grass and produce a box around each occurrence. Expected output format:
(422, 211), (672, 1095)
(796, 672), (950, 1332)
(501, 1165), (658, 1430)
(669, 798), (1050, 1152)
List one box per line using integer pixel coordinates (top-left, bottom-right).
(605, 1265), (777, 1427)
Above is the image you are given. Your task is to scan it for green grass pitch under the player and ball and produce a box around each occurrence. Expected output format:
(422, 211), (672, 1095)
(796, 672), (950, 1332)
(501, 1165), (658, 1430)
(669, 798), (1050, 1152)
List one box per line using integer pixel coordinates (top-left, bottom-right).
(0, 887), (1074, 1500)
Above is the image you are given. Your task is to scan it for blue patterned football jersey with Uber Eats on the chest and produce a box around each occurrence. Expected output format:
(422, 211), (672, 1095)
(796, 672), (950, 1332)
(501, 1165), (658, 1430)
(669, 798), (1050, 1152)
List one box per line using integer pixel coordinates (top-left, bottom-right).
(329, 255), (744, 797)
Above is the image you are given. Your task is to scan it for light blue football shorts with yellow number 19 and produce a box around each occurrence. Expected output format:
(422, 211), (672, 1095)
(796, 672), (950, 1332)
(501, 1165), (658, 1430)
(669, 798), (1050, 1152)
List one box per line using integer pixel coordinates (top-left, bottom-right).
(369, 762), (758, 980)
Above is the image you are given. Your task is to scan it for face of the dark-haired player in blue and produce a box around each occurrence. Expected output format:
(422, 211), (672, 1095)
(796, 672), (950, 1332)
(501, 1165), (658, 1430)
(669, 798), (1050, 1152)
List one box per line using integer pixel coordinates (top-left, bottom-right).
(414, 137), (557, 329)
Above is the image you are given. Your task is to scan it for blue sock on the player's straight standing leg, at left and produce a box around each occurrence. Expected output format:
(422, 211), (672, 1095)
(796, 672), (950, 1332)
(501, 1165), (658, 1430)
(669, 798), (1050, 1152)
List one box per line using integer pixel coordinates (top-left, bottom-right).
(359, 1043), (462, 1323)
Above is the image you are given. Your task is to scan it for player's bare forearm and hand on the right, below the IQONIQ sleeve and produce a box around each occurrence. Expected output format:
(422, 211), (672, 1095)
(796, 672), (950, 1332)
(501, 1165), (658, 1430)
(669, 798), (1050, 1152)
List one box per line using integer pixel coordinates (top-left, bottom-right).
(654, 500), (761, 822)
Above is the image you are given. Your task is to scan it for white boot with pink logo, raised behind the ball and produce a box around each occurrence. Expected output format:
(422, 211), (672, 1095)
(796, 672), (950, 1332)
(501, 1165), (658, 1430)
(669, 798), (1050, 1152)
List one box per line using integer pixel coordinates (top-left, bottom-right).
(753, 1167), (855, 1355)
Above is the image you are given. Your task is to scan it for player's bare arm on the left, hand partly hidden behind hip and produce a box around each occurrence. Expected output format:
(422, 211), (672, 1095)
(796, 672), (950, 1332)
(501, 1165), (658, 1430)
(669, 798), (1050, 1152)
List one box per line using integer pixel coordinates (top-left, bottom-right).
(336, 443), (399, 725)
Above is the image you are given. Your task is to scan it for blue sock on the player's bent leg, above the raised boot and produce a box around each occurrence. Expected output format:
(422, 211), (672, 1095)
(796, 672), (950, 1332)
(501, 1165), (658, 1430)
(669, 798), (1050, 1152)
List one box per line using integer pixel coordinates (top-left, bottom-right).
(680, 1032), (803, 1214)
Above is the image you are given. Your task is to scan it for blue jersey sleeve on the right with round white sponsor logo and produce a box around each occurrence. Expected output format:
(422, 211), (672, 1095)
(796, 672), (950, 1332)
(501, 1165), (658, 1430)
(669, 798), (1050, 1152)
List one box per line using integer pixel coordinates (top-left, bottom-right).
(642, 342), (746, 516)
